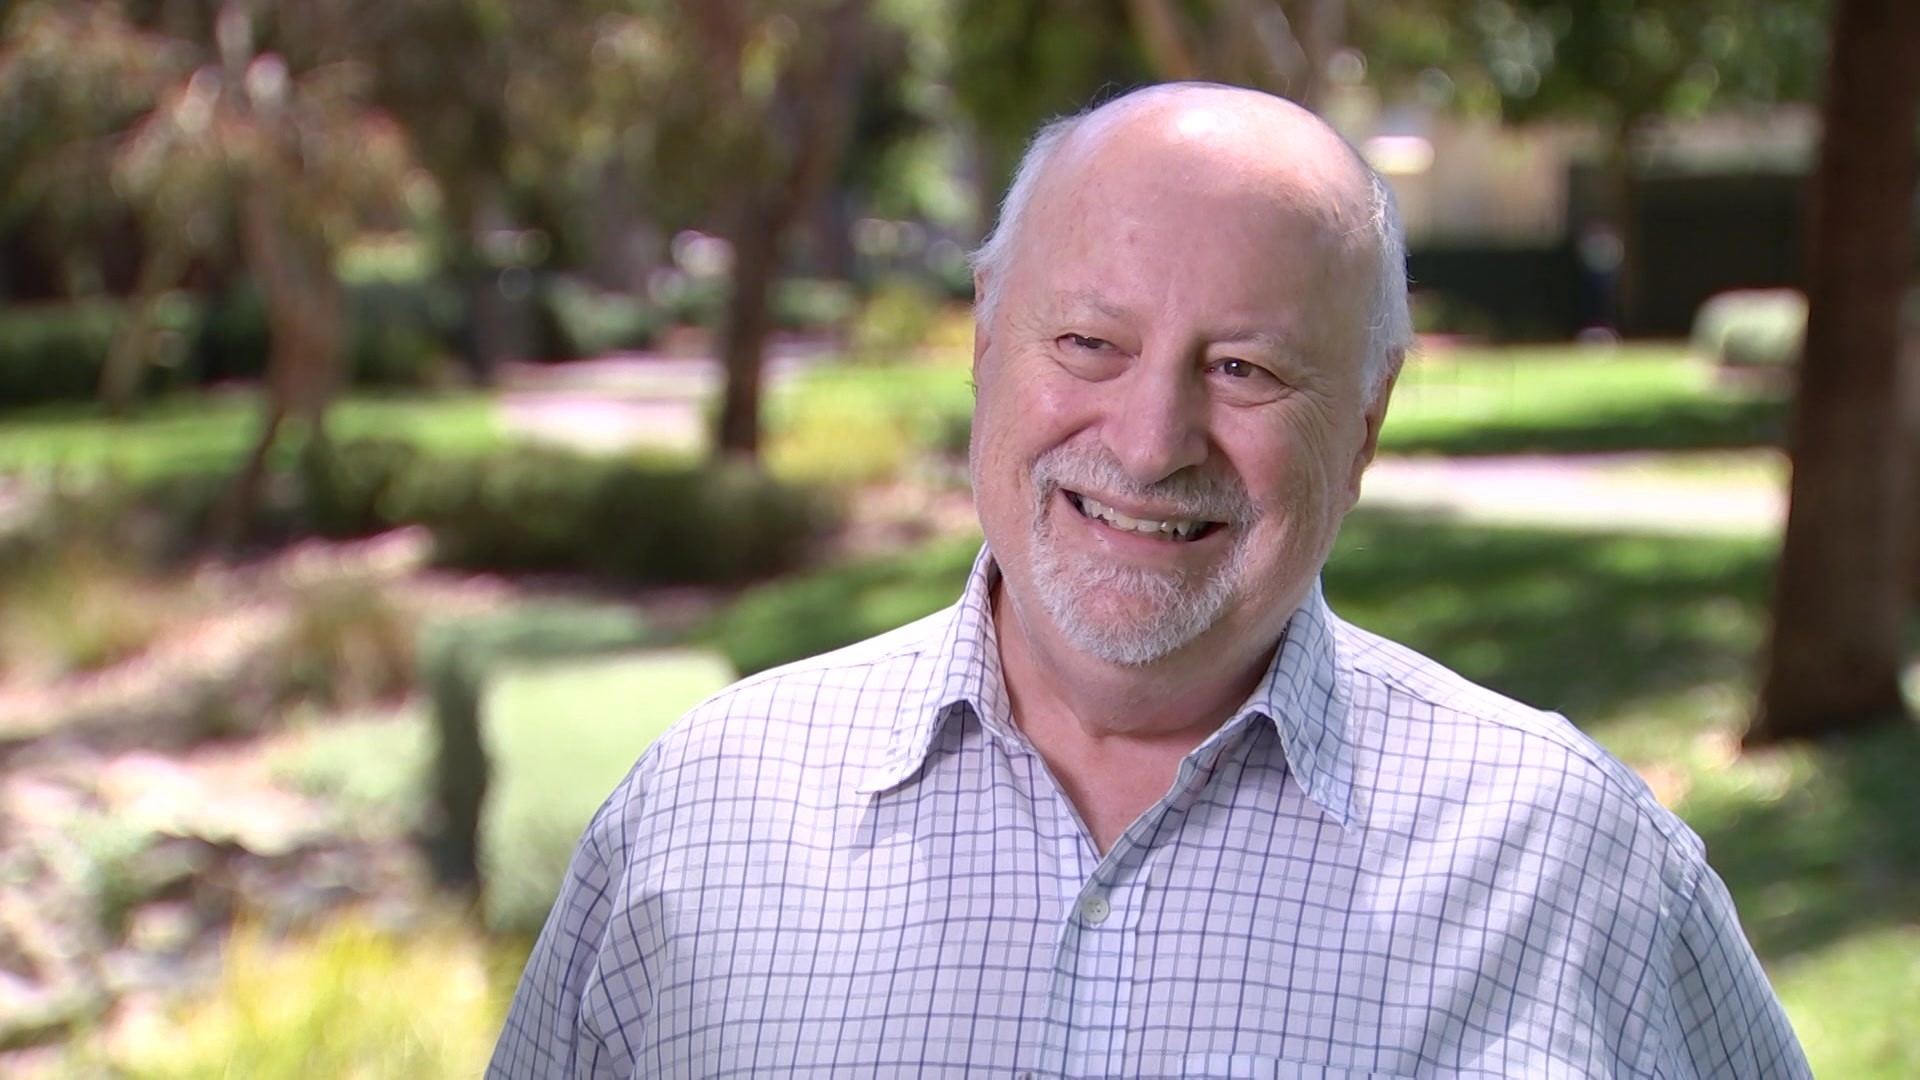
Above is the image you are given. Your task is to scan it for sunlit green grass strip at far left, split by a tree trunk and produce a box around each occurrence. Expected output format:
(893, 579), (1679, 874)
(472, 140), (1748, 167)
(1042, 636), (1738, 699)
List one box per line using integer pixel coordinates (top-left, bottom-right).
(0, 390), (503, 482)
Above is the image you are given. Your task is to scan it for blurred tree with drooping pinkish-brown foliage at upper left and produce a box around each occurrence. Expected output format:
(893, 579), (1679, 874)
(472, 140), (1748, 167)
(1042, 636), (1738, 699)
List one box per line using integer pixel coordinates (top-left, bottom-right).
(0, 0), (411, 538)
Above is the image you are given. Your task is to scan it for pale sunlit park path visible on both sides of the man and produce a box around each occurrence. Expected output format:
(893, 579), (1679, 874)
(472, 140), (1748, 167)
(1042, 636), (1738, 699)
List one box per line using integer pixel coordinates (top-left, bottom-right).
(501, 353), (1786, 536)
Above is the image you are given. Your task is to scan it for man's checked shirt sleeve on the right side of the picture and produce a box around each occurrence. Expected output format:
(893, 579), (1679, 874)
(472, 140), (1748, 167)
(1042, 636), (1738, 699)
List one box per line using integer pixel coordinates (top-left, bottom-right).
(1661, 869), (1812, 1080)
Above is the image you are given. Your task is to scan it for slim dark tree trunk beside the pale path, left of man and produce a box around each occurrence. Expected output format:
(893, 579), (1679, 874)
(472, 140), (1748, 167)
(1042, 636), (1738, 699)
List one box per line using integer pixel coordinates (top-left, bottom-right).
(714, 196), (781, 461)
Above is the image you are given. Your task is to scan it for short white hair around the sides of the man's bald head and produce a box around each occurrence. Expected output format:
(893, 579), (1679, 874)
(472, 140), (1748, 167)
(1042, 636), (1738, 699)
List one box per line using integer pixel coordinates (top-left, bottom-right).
(973, 83), (1413, 390)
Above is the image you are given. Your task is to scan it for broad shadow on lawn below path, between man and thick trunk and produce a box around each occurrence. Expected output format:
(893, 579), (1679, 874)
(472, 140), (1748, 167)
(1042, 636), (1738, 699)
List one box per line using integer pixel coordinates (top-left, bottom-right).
(1327, 511), (1772, 723)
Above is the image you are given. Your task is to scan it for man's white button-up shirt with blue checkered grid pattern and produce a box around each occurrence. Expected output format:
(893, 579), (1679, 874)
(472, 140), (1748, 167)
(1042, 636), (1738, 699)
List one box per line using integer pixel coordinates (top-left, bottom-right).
(490, 553), (1809, 1080)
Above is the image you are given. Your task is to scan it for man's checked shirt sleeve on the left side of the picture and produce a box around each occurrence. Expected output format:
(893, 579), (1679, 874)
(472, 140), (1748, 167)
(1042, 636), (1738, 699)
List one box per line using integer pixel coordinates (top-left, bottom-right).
(486, 801), (614, 1080)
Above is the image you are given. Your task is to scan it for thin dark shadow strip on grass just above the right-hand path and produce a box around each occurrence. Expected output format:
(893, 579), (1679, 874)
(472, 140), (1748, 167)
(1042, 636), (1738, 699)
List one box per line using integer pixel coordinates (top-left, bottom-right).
(1380, 400), (1788, 457)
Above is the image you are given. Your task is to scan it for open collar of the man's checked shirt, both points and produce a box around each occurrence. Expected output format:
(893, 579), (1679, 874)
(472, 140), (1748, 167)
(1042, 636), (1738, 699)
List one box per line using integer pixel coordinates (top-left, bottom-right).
(854, 548), (1354, 826)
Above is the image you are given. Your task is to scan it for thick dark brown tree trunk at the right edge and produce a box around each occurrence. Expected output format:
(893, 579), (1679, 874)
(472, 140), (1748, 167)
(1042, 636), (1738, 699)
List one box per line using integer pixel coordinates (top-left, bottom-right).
(1747, 0), (1920, 746)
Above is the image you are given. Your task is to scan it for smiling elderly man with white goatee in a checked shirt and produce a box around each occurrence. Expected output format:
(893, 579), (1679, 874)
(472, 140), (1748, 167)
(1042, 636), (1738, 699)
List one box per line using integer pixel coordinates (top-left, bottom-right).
(493, 86), (1807, 1078)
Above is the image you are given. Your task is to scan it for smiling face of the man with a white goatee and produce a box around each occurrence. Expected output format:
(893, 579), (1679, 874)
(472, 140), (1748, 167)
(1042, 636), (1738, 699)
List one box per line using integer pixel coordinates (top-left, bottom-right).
(972, 113), (1384, 665)
